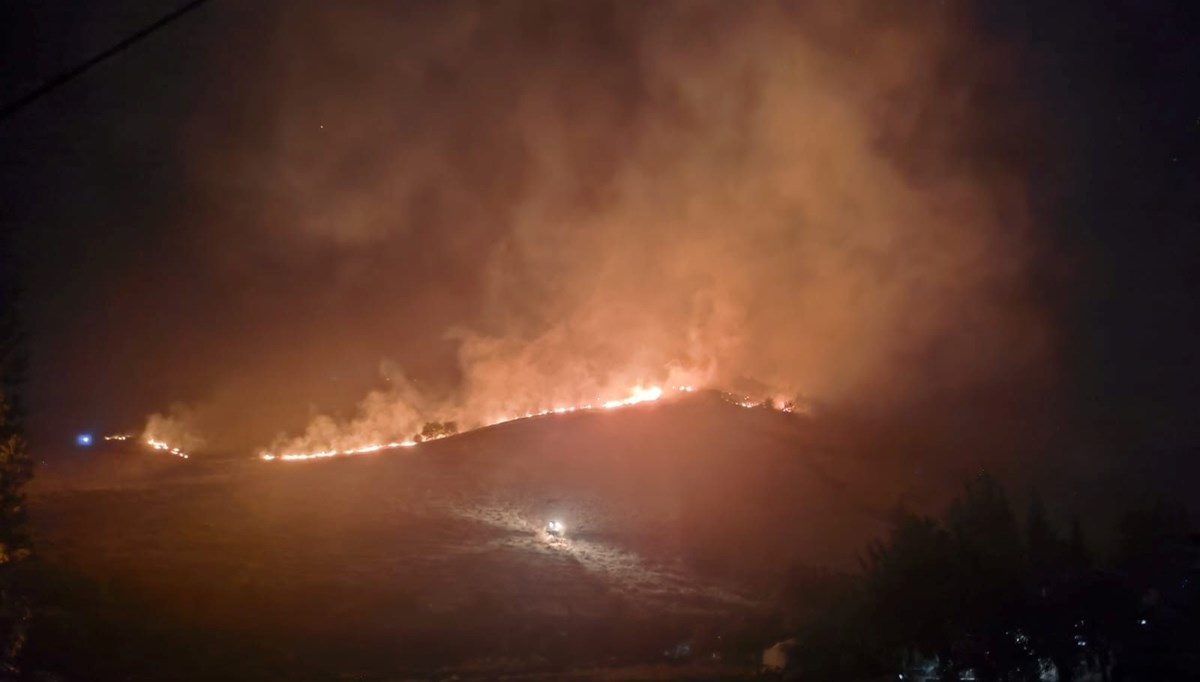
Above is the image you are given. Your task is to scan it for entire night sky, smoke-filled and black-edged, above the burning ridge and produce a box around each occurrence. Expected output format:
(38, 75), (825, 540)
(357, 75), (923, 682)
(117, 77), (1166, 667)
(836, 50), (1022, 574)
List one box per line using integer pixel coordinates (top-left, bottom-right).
(0, 0), (1200, 501)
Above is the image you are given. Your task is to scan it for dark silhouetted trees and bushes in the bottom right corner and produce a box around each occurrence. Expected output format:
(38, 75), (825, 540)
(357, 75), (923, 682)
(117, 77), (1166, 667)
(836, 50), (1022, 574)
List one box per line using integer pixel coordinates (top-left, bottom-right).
(787, 475), (1200, 681)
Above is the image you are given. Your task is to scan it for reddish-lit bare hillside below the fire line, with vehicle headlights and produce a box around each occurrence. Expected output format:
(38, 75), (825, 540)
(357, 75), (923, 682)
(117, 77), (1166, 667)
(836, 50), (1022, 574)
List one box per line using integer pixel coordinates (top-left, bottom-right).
(34, 396), (907, 672)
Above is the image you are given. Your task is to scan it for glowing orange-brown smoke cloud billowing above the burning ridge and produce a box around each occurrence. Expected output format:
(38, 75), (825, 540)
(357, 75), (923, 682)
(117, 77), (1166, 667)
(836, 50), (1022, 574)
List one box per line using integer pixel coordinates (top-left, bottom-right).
(145, 1), (1048, 458)
